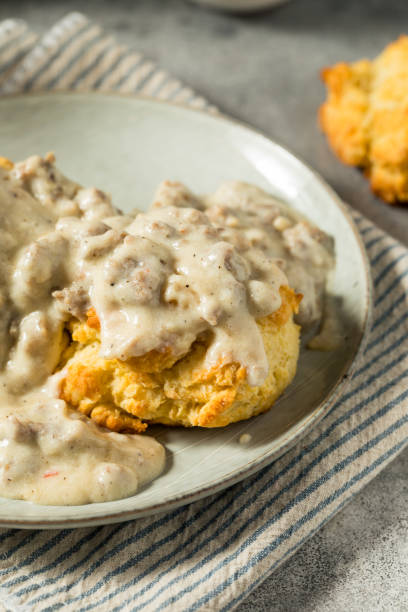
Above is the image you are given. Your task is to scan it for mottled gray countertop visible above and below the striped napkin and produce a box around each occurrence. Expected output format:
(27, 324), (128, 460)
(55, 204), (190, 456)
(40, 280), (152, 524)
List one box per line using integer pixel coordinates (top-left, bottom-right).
(0, 0), (408, 612)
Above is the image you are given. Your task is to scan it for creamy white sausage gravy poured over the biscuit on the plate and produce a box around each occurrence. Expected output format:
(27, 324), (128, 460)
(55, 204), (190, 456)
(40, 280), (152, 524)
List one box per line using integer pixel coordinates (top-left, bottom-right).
(0, 155), (333, 504)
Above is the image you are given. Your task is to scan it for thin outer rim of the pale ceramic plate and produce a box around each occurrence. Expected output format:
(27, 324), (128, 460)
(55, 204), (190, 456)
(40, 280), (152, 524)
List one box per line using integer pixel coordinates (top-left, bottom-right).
(0, 90), (373, 529)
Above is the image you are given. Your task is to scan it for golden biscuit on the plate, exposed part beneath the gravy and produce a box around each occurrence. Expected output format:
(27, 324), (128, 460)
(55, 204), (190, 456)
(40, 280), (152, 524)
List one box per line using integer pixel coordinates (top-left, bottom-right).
(60, 287), (301, 432)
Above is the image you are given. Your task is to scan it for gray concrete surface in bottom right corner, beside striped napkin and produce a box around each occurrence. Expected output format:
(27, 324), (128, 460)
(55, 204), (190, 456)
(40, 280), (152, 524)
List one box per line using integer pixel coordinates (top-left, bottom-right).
(238, 451), (408, 612)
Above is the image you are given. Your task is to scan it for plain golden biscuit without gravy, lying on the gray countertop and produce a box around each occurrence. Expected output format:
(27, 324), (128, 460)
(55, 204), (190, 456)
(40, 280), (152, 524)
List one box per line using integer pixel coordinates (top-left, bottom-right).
(319, 36), (408, 204)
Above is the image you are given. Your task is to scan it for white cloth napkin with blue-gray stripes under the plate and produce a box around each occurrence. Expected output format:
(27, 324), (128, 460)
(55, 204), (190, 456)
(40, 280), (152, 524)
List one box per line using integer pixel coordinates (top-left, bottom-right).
(0, 13), (408, 612)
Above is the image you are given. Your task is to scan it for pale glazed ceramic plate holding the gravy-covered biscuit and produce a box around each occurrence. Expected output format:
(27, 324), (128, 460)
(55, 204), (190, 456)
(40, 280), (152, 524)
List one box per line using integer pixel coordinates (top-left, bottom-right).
(0, 93), (370, 528)
